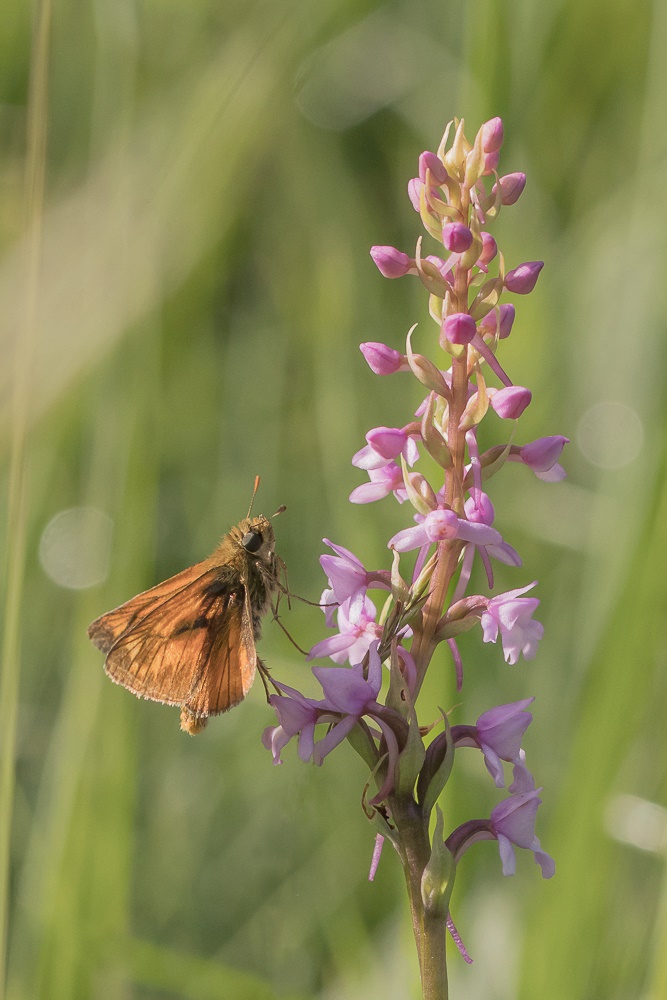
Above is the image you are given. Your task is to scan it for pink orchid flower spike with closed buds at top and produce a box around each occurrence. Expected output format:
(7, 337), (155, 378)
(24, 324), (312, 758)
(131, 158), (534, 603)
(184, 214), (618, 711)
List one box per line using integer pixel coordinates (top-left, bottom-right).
(264, 118), (568, 960)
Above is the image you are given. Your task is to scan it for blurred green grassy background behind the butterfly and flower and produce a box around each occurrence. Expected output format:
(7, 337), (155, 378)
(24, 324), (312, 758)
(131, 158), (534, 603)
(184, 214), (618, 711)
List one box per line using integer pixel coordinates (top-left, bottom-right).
(0, 0), (667, 1000)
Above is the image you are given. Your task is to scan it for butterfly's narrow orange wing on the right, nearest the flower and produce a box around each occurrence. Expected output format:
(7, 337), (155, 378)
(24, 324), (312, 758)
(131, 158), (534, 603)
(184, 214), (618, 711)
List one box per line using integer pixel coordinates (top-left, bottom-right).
(185, 587), (257, 718)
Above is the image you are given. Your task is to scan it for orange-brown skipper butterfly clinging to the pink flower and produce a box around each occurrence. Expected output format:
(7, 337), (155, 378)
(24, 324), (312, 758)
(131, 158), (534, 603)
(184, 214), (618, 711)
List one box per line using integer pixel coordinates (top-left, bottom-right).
(88, 481), (285, 735)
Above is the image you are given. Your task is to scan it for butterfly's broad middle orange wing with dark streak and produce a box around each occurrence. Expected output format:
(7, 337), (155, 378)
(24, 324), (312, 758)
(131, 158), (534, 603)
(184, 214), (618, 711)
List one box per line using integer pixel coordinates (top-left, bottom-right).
(98, 567), (236, 705)
